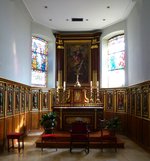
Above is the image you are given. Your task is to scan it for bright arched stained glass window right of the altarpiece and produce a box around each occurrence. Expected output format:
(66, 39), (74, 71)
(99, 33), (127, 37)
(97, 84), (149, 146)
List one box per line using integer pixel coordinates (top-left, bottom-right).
(102, 34), (125, 88)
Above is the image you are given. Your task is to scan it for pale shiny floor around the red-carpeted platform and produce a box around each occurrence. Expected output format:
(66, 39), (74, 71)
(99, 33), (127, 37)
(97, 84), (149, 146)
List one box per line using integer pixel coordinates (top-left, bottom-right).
(0, 133), (150, 161)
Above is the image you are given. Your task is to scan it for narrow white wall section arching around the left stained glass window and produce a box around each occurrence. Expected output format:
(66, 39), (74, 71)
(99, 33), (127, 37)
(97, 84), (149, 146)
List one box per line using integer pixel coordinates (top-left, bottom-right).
(32, 22), (56, 88)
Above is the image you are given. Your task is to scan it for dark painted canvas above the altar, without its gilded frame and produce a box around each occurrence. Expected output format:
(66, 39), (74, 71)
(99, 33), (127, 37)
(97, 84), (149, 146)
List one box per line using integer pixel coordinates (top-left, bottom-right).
(66, 44), (90, 84)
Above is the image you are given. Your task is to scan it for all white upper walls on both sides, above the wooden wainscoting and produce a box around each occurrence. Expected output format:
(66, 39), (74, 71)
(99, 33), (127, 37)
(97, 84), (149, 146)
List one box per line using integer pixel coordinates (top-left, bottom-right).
(0, 0), (150, 87)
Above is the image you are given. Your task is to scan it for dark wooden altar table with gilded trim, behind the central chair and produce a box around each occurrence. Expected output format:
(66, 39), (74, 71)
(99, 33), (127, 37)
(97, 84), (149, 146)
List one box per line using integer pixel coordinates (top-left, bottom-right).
(53, 106), (103, 131)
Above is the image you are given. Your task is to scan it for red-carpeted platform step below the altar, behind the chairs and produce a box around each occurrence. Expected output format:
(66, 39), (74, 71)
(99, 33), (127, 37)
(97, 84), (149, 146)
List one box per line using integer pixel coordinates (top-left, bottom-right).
(36, 131), (124, 149)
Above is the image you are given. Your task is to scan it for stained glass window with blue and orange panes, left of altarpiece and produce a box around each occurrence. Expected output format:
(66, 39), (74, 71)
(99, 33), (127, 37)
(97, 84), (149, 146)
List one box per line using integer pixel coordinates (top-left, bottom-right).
(31, 37), (48, 87)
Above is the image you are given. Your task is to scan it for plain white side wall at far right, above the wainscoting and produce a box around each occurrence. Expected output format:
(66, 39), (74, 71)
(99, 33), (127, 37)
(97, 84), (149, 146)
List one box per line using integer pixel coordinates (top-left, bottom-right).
(127, 0), (150, 85)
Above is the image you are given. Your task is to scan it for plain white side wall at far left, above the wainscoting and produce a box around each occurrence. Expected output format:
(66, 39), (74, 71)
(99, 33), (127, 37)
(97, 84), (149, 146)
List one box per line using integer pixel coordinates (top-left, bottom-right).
(0, 0), (31, 85)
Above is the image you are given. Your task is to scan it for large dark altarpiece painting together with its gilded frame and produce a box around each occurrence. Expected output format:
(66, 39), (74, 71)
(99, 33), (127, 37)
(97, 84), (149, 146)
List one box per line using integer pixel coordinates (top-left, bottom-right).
(64, 40), (91, 86)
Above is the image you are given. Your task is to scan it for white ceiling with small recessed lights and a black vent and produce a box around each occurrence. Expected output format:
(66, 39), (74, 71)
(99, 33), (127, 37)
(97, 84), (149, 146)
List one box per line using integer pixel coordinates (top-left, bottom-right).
(23, 0), (135, 31)
